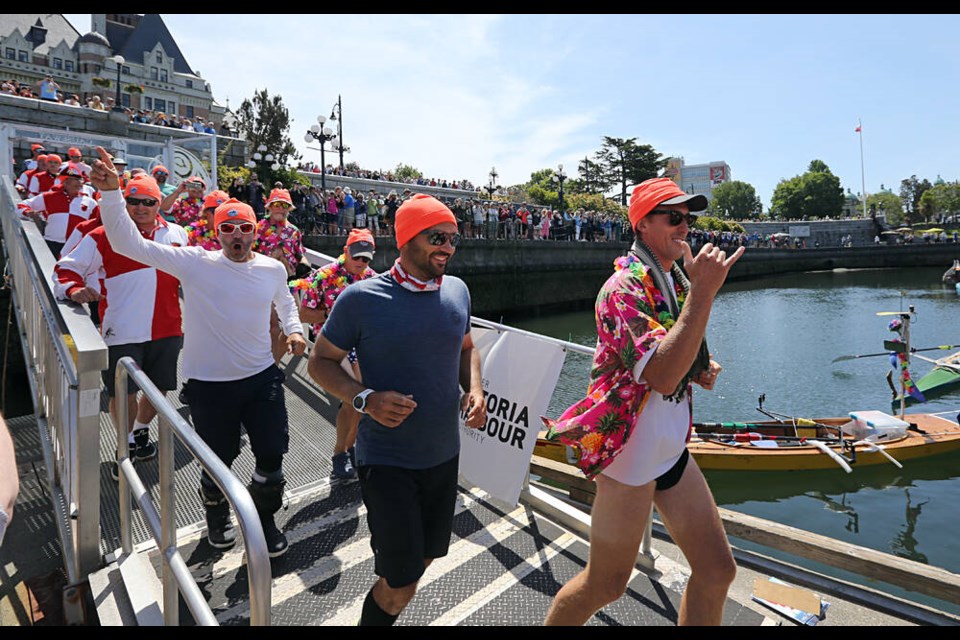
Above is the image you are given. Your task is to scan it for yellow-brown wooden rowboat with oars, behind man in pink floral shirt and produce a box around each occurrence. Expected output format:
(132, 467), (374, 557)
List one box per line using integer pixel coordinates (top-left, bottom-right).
(534, 412), (960, 471)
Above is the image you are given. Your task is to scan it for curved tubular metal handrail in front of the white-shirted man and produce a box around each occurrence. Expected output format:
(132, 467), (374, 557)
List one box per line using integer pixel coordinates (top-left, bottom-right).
(116, 356), (271, 626)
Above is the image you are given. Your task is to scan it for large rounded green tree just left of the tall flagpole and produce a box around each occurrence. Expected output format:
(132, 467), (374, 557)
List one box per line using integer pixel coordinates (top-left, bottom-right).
(770, 160), (843, 220)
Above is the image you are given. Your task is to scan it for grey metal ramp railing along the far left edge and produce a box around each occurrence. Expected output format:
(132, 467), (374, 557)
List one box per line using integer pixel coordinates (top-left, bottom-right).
(0, 180), (107, 583)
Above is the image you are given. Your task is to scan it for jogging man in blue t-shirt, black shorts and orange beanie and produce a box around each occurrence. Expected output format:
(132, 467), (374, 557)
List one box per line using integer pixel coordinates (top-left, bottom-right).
(309, 194), (486, 626)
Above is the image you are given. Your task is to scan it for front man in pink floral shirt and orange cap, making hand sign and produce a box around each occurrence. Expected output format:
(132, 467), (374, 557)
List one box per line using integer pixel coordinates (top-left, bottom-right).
(545, 178), (744, 625)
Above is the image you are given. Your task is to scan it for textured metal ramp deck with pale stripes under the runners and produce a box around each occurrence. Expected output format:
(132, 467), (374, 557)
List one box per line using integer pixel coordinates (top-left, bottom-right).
(90, 350), (765, 626)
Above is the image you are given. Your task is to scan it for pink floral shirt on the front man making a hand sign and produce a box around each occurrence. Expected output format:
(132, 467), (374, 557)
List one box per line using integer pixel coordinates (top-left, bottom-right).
(543, 254), (693, 478)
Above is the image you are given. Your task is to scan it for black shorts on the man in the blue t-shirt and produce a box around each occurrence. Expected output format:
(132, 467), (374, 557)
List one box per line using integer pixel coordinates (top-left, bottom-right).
(358, 456), (460, 589)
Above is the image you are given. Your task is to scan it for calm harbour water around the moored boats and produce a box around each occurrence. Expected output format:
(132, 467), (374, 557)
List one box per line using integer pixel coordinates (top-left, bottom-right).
(504, 268), (960, 613)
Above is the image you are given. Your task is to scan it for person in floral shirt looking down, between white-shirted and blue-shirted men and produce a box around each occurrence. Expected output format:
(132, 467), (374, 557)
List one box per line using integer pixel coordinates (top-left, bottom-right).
(291, 229), (377, 480)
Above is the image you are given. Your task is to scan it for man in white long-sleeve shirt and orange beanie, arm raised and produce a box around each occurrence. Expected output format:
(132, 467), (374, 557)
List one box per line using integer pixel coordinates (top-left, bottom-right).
(90, 147), (306, 557)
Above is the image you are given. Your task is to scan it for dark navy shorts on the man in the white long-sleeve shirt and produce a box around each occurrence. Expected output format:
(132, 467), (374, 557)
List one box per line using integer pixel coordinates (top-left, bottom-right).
(186, 364), (290, 467)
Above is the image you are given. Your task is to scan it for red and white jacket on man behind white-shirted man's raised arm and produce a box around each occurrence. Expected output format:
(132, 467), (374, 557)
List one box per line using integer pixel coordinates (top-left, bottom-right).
(53, 216), (187, 345)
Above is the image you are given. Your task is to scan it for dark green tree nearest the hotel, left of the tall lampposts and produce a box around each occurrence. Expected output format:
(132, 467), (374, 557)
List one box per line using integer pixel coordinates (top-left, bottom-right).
(236, 89), (300, 185)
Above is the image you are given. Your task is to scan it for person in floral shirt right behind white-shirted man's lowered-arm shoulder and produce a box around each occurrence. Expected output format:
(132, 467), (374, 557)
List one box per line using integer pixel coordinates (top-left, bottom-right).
(253, 188), (311, 364)
